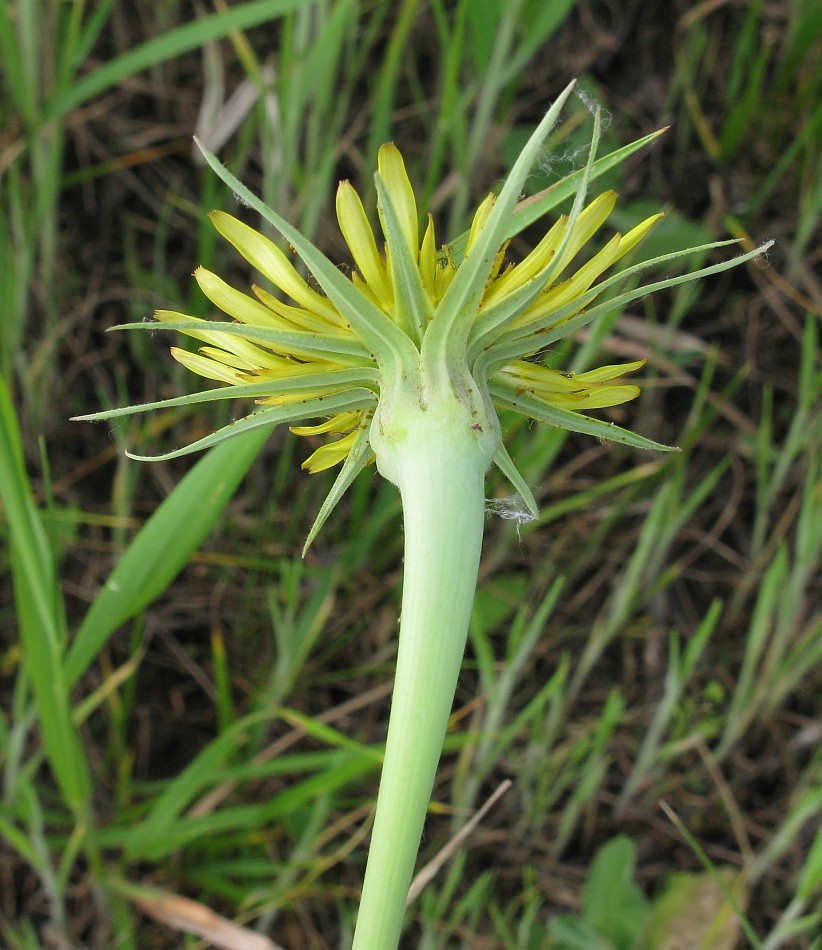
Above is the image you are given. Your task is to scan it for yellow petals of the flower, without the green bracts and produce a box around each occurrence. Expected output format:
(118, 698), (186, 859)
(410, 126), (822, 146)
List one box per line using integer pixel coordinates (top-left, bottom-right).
(157, 144), (661, 480)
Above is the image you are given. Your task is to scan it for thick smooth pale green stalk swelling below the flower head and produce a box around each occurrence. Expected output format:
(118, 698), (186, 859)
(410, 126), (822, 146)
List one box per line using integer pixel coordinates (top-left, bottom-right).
(354, 392), (490, 950)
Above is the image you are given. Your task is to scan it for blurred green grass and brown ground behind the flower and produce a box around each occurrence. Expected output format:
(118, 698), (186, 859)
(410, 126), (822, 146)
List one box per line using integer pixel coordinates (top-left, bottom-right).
(0, 0), (822, 950)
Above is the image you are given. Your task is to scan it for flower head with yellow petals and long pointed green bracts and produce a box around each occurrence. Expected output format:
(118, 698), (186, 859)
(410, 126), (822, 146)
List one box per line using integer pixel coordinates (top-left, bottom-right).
(79, 87), (772, 552)
